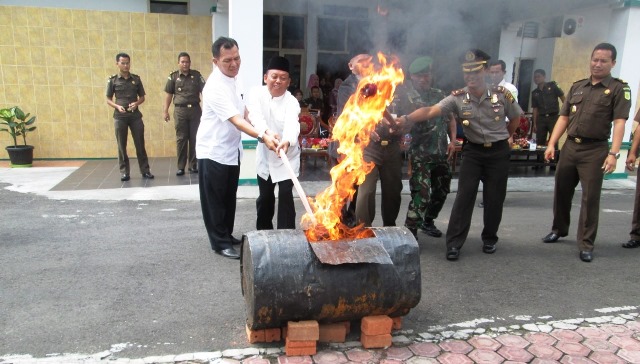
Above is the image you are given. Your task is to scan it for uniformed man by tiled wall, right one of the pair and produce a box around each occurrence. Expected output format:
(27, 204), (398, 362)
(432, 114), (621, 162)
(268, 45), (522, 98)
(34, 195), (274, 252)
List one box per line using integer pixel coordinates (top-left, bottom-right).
(164, 52), (205, 176)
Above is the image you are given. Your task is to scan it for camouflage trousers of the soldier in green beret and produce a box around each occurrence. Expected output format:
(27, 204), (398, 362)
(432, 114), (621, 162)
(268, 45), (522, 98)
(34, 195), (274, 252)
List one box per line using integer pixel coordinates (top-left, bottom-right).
(404, 158), (451, 229)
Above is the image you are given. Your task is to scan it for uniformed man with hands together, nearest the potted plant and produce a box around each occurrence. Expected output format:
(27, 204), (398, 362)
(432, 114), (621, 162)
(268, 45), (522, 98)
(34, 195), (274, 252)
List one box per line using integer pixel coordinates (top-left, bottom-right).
(106, 53), (153, 181)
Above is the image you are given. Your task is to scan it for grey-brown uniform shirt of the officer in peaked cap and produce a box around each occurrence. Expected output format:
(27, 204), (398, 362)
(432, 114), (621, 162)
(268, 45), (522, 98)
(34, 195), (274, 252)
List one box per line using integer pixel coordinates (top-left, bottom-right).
(438, 86), (522, 144)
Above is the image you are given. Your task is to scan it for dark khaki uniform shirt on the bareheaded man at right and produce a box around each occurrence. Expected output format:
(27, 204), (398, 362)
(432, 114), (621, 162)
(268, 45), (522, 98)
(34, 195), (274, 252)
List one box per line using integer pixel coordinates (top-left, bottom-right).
(560, 75), (631, 140)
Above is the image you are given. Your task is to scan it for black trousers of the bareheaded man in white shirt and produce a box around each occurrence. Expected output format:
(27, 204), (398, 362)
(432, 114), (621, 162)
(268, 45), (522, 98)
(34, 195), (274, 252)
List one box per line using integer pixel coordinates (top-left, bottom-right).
(198, 159), (240, 251)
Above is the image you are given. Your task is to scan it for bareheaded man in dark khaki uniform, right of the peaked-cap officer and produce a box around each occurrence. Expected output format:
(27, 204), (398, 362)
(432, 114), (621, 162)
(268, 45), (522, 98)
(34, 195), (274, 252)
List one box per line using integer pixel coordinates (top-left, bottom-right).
(542, 43), (631, 262)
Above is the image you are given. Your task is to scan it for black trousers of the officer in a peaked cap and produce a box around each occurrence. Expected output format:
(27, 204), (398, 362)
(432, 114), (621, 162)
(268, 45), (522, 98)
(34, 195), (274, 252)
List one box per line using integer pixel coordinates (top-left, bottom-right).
(447, 140), (511, 248)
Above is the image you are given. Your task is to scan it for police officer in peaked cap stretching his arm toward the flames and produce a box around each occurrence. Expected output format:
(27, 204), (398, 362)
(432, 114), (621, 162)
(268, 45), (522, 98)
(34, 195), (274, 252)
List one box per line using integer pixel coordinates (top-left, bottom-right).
(396, 49), (522, 260)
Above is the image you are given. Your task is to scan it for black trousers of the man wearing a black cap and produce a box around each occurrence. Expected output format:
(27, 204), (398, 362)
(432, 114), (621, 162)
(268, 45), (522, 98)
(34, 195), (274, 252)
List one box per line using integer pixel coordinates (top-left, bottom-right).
(256, 176), (296, 230)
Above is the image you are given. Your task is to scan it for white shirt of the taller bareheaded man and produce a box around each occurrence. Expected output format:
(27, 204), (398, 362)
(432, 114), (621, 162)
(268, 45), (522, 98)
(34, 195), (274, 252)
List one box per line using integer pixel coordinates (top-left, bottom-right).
(196, 67), (245, 166)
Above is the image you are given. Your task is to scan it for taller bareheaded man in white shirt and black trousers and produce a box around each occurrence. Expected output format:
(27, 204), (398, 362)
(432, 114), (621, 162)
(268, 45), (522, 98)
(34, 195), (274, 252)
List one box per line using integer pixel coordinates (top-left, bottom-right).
(196, 37), (278, 259)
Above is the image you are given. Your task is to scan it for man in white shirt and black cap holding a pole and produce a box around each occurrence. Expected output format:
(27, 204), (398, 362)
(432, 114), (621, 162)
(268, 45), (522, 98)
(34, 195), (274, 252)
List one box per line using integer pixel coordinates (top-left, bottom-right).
(247, 56), (300, 230)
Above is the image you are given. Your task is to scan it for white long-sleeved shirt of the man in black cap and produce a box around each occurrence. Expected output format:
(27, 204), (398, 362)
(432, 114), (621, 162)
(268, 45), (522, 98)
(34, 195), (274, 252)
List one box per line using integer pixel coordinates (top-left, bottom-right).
(247, 86), (300, 183)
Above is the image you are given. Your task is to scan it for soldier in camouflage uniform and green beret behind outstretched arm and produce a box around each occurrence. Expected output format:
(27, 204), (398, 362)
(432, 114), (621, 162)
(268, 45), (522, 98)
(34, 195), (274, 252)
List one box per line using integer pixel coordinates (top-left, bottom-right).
(396, 57), (456, 237)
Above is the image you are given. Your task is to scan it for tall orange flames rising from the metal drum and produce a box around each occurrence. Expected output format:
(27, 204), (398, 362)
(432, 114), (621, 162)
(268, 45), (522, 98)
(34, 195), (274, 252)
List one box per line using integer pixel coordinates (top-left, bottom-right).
(302, 53), (404, 242)
